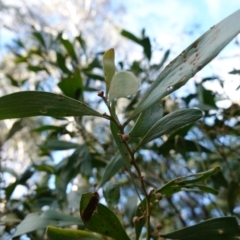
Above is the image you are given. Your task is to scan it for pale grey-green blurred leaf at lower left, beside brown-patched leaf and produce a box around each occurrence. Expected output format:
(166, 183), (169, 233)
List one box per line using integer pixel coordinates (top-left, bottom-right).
(13, 210), (83, 237)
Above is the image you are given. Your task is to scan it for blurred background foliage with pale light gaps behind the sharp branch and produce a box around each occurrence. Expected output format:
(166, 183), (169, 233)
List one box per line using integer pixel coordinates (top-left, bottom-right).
(0, 0), (240, 239)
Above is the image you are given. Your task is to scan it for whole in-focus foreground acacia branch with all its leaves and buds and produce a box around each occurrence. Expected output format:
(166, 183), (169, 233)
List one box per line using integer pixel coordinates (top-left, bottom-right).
(0, 10), (240, 240)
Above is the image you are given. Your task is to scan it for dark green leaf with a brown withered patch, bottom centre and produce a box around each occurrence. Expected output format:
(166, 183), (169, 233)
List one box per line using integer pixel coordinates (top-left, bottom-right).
(80, 193), (129, 240)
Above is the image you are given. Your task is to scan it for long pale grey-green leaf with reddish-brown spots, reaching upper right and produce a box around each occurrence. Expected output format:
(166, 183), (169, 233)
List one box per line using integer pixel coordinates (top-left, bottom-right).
(128, 10), (240, 121)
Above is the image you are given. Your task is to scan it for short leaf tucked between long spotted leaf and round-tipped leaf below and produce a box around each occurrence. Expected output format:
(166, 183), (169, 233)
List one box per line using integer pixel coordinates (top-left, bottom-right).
(129, 102), (163, 137)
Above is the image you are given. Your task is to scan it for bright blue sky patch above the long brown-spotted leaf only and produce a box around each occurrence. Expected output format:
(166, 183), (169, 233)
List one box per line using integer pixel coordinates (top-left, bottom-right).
(123, 0), (240, 47)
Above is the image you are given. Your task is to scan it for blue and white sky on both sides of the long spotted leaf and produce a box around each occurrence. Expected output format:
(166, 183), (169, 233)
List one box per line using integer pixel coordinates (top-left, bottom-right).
(114, 0), (240, 103)
